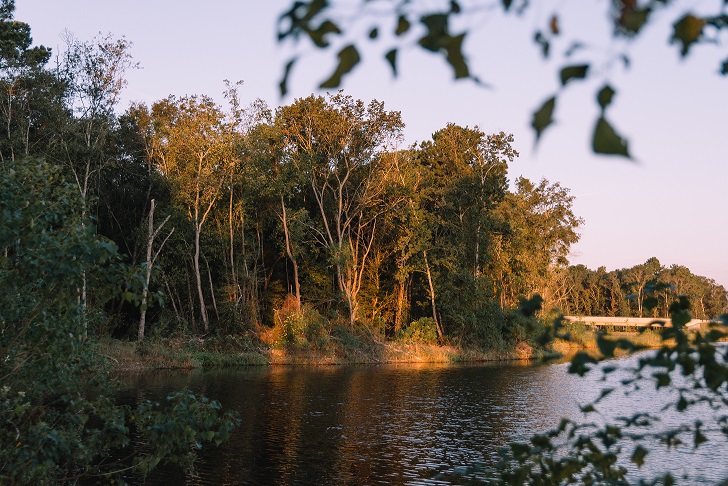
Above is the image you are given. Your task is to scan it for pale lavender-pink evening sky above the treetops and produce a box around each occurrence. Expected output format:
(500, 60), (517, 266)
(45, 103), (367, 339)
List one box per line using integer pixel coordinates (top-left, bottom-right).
(15, 0), (728, 287)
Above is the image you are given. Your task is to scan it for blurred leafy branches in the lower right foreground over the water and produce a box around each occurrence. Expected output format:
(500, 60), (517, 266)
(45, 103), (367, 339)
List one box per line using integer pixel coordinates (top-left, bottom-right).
(486, 297), (728, 484)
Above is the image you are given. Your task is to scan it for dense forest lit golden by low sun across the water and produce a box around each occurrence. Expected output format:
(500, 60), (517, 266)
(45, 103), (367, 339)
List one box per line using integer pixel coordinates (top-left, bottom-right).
(0, 6), (726, 354)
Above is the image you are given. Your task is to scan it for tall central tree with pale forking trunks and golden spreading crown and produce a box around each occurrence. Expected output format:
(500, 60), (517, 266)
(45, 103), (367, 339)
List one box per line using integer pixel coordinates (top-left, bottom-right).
(276, 93), (402, 325)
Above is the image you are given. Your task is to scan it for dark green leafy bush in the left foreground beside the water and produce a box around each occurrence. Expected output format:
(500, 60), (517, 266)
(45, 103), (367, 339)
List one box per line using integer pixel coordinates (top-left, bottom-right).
(0, 159), (235, 484)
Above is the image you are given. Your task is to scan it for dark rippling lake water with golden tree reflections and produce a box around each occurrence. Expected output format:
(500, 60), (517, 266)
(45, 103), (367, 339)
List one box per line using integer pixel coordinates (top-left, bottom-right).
(123, 358), (728, 485)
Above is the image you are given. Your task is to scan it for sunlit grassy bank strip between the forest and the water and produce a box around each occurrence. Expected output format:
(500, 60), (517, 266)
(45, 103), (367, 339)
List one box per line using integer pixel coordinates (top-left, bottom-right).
(100, 326), (680, 371)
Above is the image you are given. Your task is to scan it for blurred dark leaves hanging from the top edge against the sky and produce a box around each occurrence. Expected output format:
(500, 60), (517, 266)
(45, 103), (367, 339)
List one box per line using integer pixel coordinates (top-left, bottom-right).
(278, 0), (728, 157)
